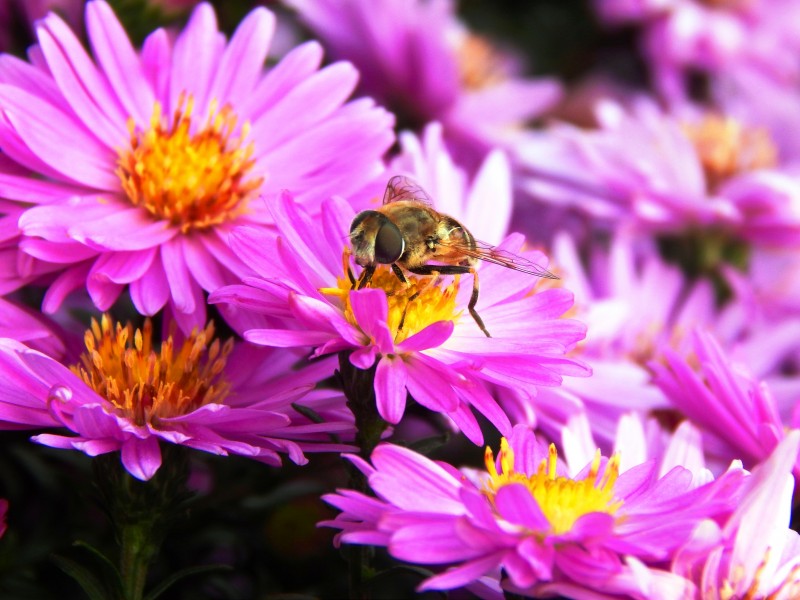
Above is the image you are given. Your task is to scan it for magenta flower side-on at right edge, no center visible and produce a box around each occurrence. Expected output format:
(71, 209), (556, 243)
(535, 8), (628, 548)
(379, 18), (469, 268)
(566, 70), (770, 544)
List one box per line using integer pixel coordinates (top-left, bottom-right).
(651, 329), (800, 475)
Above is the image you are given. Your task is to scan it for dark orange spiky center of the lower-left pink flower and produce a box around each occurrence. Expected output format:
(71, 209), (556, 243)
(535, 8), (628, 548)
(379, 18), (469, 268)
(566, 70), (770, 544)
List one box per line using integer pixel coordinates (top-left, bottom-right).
(71, 315), (233, 427)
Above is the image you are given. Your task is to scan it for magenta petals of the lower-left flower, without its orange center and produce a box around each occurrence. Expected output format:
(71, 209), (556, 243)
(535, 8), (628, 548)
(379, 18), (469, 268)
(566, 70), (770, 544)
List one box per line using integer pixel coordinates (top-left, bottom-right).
(0, 324), (353, 480)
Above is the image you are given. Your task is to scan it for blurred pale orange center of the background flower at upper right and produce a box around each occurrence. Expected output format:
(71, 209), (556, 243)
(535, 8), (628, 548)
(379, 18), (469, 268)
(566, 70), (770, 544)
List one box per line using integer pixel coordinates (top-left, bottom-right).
(683, 115), (778, 191)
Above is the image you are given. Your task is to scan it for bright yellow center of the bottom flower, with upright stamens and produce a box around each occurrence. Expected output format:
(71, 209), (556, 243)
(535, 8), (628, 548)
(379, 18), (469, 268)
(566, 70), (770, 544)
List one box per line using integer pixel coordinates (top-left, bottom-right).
(484, 438), (622, 535)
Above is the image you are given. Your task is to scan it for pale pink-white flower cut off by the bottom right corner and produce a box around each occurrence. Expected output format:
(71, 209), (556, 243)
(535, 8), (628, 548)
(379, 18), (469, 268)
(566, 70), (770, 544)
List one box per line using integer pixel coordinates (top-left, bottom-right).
(672, 431), (800, 600)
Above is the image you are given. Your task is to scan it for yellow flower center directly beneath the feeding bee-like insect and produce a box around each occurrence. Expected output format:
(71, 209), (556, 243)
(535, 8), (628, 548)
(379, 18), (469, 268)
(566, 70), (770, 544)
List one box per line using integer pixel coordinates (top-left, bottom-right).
(320, 254), (462, 344)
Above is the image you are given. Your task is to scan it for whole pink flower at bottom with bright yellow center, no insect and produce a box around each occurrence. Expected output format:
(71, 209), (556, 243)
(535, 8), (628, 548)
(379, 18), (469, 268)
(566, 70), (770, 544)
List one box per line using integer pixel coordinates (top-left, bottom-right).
(322, 426), (744, 599)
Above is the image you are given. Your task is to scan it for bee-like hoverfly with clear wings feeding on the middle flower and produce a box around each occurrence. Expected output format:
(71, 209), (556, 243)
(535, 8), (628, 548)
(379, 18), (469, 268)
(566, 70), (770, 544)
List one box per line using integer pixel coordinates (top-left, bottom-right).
(350, 175), (558, 337)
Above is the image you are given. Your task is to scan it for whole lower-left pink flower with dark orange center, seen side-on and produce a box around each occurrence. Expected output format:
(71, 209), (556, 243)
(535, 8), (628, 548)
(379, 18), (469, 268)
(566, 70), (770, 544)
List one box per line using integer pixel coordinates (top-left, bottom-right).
(0, 317), (353, 480)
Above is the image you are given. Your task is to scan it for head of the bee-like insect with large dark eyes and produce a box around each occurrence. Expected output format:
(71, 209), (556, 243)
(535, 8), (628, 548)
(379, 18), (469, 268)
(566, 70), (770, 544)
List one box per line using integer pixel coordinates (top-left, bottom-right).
(350, 210), (406, 267)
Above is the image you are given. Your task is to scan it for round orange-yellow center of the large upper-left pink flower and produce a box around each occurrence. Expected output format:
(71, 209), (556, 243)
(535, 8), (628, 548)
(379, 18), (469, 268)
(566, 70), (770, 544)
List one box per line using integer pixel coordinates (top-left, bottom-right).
(116, 96), (263, 233)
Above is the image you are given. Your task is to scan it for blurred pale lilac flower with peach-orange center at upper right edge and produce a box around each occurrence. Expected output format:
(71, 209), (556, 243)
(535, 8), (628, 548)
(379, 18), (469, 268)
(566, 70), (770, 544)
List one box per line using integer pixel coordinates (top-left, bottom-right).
(518, 101), (800, 245)
